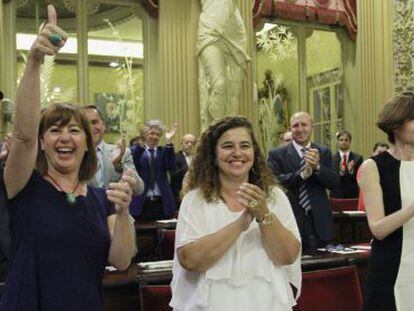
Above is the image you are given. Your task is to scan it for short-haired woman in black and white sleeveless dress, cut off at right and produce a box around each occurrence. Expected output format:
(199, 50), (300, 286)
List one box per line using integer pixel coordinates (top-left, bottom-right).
(360, 91), (414, 311)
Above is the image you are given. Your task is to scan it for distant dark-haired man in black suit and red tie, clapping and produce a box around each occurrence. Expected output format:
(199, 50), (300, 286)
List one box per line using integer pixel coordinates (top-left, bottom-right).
(331, 130), (363, 199)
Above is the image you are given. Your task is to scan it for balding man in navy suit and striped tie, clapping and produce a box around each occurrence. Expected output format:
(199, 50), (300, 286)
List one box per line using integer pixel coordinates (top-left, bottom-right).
(268, 112), (338, 249)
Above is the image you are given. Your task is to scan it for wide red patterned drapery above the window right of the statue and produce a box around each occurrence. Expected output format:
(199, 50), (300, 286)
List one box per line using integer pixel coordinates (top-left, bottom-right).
(253, 0), (357, 40)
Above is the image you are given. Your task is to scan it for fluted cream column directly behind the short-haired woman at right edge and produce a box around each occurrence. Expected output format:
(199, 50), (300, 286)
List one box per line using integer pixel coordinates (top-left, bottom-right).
(353, 0), (393, 156)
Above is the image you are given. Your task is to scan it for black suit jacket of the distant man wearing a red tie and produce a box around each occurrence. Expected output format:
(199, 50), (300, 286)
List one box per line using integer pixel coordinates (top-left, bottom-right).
(331, 151), (363, 199)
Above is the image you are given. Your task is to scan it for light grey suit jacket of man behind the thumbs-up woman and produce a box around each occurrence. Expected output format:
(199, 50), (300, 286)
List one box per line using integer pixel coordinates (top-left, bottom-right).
(88, 142), (144, 195)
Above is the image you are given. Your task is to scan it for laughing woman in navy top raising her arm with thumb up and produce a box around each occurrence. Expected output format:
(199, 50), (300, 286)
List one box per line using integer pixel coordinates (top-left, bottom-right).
(0, 5), (134, 311)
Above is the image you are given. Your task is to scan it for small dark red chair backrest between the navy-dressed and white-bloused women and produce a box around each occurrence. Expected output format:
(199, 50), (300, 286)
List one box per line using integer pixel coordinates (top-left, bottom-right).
(139, 285), (172, 311)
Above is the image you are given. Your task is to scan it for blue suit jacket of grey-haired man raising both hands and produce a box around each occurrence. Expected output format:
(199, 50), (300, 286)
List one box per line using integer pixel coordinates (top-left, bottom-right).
(131, 145), (177, 216)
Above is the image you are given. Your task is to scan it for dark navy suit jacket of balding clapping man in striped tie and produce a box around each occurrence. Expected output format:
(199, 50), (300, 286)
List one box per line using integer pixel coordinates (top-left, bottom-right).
(268, 143), (339, 241)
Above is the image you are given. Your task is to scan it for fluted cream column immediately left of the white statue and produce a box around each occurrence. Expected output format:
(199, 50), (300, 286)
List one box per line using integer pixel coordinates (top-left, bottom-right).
(158, 0), (200, 143)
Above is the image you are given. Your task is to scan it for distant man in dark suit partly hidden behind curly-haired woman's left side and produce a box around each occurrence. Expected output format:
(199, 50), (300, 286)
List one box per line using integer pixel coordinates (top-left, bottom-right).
(171, 133), (196, 207)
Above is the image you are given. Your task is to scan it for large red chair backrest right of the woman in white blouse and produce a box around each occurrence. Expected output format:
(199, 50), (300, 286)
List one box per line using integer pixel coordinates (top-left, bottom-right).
(294, 266), (362, 311)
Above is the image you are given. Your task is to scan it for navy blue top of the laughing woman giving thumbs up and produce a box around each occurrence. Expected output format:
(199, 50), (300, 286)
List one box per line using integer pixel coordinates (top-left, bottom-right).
(0, 171), (115, 311)
